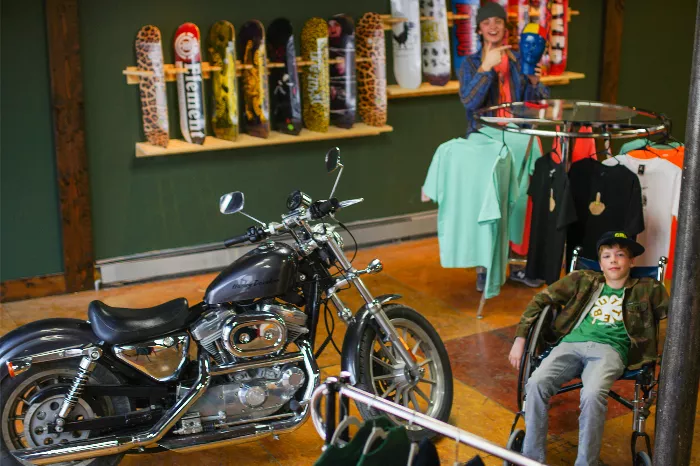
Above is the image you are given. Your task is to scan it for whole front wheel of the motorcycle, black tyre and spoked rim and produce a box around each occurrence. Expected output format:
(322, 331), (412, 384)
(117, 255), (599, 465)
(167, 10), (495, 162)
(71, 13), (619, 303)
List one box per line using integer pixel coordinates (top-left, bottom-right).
(357, 304), (453, 440)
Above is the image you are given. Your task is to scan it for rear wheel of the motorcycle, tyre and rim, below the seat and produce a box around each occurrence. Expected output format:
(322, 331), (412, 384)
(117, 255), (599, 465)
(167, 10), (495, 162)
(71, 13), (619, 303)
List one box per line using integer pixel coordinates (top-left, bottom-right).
(0, 358), (131, 466)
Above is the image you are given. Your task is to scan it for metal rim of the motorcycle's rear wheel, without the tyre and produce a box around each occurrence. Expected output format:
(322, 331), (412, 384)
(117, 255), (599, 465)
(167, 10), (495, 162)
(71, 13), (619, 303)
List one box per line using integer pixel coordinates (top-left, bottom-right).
(2, 369), (100, 466)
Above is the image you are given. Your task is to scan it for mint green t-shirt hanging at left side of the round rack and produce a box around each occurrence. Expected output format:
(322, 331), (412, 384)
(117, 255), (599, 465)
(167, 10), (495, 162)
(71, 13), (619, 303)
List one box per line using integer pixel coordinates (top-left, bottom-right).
(423, 132), (517, 298)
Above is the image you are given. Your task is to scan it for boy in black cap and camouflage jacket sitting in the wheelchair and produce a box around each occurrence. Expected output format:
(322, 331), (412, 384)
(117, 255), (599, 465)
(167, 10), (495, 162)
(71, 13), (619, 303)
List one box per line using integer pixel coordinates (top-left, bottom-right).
(508, 232), (669, 466)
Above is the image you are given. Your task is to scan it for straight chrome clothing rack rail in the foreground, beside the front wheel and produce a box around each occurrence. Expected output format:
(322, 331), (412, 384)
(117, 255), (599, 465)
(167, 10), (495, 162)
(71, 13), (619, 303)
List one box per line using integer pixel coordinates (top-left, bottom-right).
(310, 372), (544, 466)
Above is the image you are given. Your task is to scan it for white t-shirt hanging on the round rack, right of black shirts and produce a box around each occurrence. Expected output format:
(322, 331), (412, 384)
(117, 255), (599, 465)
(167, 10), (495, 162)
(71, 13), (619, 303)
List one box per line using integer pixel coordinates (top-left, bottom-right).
(603, 154), (682, 266)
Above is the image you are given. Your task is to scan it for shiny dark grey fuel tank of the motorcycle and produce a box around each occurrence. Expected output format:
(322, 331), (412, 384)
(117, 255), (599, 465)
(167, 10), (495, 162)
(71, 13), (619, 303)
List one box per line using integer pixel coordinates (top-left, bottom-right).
(204, 241), (297, 304)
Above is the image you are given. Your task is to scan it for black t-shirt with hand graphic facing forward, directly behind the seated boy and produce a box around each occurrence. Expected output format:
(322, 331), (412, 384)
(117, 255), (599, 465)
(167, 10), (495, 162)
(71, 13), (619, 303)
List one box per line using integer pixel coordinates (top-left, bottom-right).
(566, 159), (644, 263)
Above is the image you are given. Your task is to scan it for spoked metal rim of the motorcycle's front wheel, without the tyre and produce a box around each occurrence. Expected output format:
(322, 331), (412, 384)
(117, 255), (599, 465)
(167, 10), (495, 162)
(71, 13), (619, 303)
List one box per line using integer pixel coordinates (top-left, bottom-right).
(369, 318), (445, 422)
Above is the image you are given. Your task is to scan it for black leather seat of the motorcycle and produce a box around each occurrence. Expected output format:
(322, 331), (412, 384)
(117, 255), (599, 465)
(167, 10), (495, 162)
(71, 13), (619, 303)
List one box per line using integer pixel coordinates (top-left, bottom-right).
(88, 298), (189, 345)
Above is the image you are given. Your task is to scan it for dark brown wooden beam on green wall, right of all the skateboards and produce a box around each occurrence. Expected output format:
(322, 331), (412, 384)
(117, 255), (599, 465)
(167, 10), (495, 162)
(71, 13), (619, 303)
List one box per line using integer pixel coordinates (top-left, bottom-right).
(600, 0), (625, 103)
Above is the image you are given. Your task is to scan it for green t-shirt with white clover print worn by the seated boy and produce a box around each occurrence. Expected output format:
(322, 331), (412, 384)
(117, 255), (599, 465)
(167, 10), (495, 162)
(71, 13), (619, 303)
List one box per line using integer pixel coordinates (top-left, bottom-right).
(562, 284), (630, 366)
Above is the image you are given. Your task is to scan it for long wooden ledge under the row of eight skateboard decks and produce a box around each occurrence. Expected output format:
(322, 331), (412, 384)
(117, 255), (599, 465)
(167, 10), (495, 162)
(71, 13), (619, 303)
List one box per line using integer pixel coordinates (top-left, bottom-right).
(136, 123), (394, 157)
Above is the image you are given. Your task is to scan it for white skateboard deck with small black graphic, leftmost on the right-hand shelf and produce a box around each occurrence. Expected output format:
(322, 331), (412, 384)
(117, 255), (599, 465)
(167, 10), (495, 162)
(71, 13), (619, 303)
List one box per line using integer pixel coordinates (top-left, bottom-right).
(391, 0), (422, 89)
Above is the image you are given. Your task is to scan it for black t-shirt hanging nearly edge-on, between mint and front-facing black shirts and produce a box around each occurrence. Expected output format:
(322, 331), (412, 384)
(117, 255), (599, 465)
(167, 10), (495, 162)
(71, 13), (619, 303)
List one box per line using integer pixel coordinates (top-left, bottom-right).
(525, 154), (576, 284)
